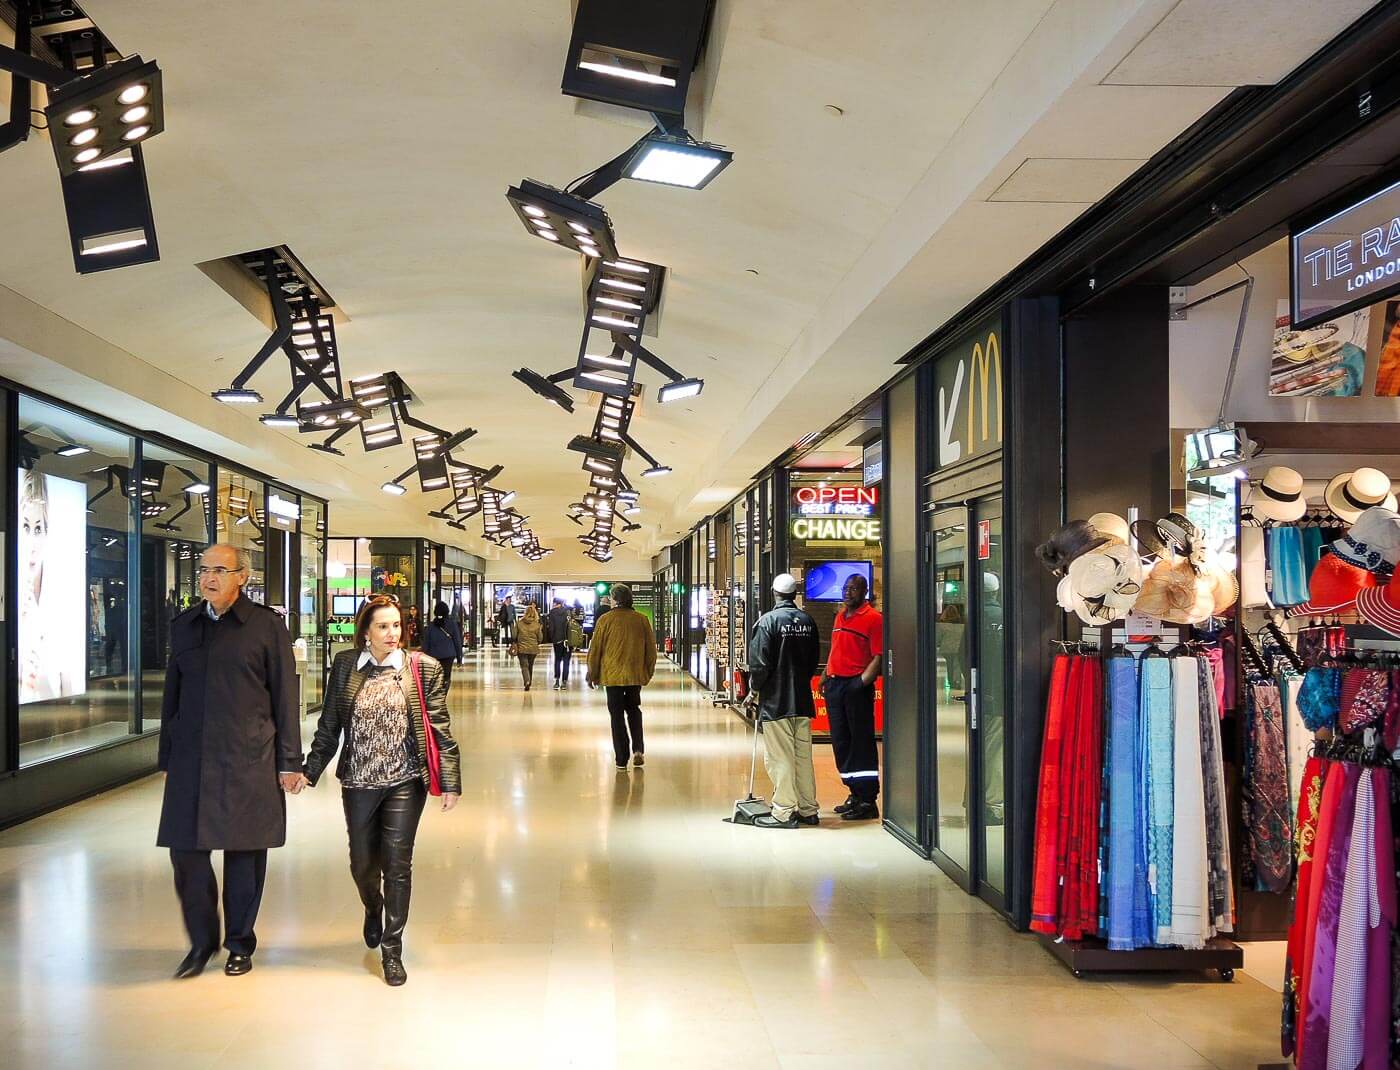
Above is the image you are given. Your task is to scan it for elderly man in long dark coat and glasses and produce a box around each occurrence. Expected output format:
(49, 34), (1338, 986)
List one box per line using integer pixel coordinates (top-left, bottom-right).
(155, 543), (305, 978)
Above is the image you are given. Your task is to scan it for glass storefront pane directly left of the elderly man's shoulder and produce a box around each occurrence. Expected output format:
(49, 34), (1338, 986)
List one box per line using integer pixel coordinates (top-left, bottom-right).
(141, 443), (210, 731)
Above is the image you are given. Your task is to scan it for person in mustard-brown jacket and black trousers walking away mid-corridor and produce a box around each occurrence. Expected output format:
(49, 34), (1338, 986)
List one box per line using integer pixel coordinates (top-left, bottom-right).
(588, 583), (657, 773)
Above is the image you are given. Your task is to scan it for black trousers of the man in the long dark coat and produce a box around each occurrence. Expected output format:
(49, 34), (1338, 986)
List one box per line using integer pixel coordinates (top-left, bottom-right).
(171, 847), (267, 955)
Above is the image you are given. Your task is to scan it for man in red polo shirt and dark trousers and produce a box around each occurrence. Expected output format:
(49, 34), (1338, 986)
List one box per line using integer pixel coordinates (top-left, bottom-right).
(822, 576), (885, 821)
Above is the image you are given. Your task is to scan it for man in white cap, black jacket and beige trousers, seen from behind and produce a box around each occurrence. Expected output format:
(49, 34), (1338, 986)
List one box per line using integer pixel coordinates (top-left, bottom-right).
(749, 573), (822, 829)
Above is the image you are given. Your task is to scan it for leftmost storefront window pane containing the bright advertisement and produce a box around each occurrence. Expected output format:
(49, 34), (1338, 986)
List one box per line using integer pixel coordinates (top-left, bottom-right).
(15, 396), (143, 766)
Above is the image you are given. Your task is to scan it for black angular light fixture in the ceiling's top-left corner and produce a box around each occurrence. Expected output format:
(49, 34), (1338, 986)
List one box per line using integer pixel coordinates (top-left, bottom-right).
(0, 0), (165, 275)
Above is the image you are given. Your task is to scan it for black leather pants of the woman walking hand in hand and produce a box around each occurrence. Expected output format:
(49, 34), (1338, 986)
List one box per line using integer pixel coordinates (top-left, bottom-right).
(340, 779), (427, 955)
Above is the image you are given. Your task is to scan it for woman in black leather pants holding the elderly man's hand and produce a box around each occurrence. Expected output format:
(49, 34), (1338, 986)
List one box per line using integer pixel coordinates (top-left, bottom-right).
(305, 595), (462, 986)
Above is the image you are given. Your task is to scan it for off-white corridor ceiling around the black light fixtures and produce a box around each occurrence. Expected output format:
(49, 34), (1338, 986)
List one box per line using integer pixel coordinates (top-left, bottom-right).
(0, 0), (1377, 576)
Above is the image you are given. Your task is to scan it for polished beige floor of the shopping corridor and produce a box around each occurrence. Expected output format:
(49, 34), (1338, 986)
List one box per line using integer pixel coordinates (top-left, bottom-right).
(0, 653), (1278, 1070)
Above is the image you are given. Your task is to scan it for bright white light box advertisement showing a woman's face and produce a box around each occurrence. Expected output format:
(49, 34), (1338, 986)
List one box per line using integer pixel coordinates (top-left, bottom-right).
(18, 469), (87, 704)
